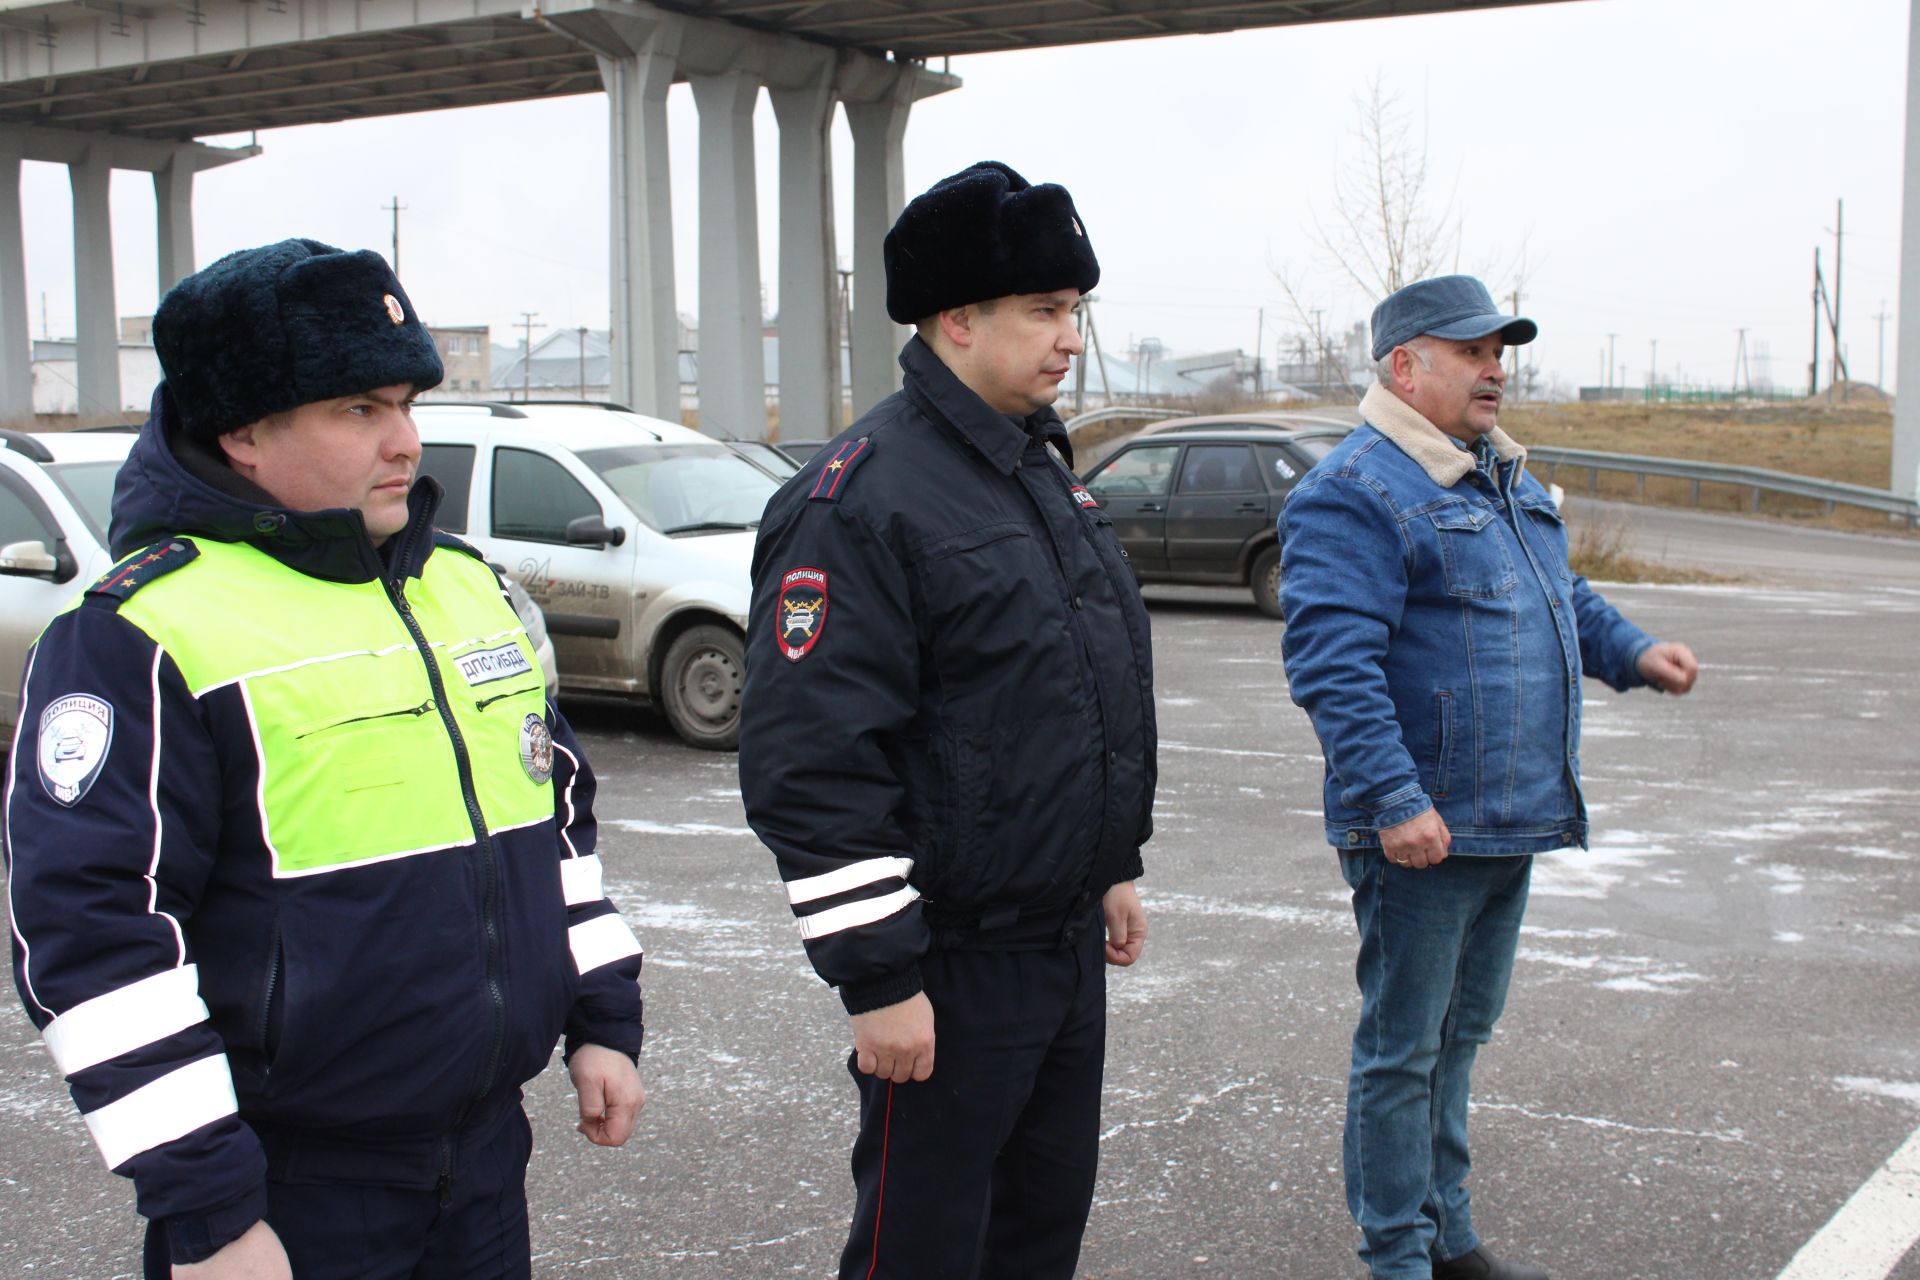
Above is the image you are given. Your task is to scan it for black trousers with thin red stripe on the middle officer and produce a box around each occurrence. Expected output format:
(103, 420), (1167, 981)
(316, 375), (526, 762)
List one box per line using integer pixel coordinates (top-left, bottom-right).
(839, 912), (1106, 1280)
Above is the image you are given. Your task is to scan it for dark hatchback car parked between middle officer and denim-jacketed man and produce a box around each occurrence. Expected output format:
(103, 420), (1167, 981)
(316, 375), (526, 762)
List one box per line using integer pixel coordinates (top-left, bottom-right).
(1083, 422), (1346, 618)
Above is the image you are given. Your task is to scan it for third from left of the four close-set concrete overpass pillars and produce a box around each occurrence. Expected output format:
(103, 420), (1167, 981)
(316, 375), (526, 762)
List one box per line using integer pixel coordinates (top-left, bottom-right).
(768, 63), (841, 439)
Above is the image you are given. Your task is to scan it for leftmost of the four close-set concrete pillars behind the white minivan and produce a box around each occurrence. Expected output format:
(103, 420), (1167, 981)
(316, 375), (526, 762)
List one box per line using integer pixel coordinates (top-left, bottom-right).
(599, 37), (680, 422)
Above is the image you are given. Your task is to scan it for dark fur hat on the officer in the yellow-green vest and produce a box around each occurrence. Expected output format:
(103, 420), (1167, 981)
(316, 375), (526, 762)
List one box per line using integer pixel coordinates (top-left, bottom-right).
(154, 240), (445, 443)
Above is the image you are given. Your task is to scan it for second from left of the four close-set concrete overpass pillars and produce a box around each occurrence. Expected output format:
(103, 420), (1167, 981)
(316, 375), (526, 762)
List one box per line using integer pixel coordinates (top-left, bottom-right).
(693, 69), (766, 439)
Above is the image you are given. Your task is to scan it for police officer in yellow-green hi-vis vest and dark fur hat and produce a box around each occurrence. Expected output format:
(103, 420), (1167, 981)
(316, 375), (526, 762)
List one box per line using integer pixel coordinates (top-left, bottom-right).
(6, 240), (645, 1280)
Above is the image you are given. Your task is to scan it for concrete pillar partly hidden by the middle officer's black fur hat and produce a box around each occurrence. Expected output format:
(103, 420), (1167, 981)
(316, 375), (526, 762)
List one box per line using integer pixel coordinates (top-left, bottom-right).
(847, 84), (910, 415)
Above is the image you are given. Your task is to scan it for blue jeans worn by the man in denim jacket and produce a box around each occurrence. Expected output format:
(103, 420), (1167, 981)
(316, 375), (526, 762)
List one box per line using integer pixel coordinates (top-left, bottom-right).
(1340, 848), (1534, 1280)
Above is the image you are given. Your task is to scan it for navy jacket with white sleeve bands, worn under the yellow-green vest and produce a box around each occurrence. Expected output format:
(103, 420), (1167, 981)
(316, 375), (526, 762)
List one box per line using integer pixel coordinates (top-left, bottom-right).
(6, 388), (641, 1263)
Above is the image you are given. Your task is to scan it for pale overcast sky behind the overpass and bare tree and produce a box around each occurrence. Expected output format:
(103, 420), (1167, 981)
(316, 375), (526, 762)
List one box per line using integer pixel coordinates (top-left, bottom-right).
(11, 0), (1908, 397)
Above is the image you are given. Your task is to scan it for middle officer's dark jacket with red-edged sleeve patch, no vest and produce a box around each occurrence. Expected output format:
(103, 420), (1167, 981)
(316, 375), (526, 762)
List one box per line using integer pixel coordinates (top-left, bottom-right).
(739, 338), (1156, 1013)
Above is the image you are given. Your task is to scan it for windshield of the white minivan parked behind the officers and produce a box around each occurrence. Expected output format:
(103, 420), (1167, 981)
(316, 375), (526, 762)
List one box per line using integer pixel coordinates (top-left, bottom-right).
(580, 445), (780, 533)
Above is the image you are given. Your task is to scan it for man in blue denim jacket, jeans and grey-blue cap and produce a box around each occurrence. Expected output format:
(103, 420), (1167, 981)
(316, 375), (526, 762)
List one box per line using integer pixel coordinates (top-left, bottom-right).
(1281, 276), (1699, 1280)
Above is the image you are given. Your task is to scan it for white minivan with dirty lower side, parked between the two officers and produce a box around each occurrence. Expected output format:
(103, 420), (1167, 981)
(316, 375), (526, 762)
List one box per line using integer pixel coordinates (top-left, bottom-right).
(413, 403), (780, 750)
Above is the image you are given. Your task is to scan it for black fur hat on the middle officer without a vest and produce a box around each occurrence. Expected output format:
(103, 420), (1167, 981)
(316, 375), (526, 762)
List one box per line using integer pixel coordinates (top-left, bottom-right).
(883, 159), (1100, 324)
